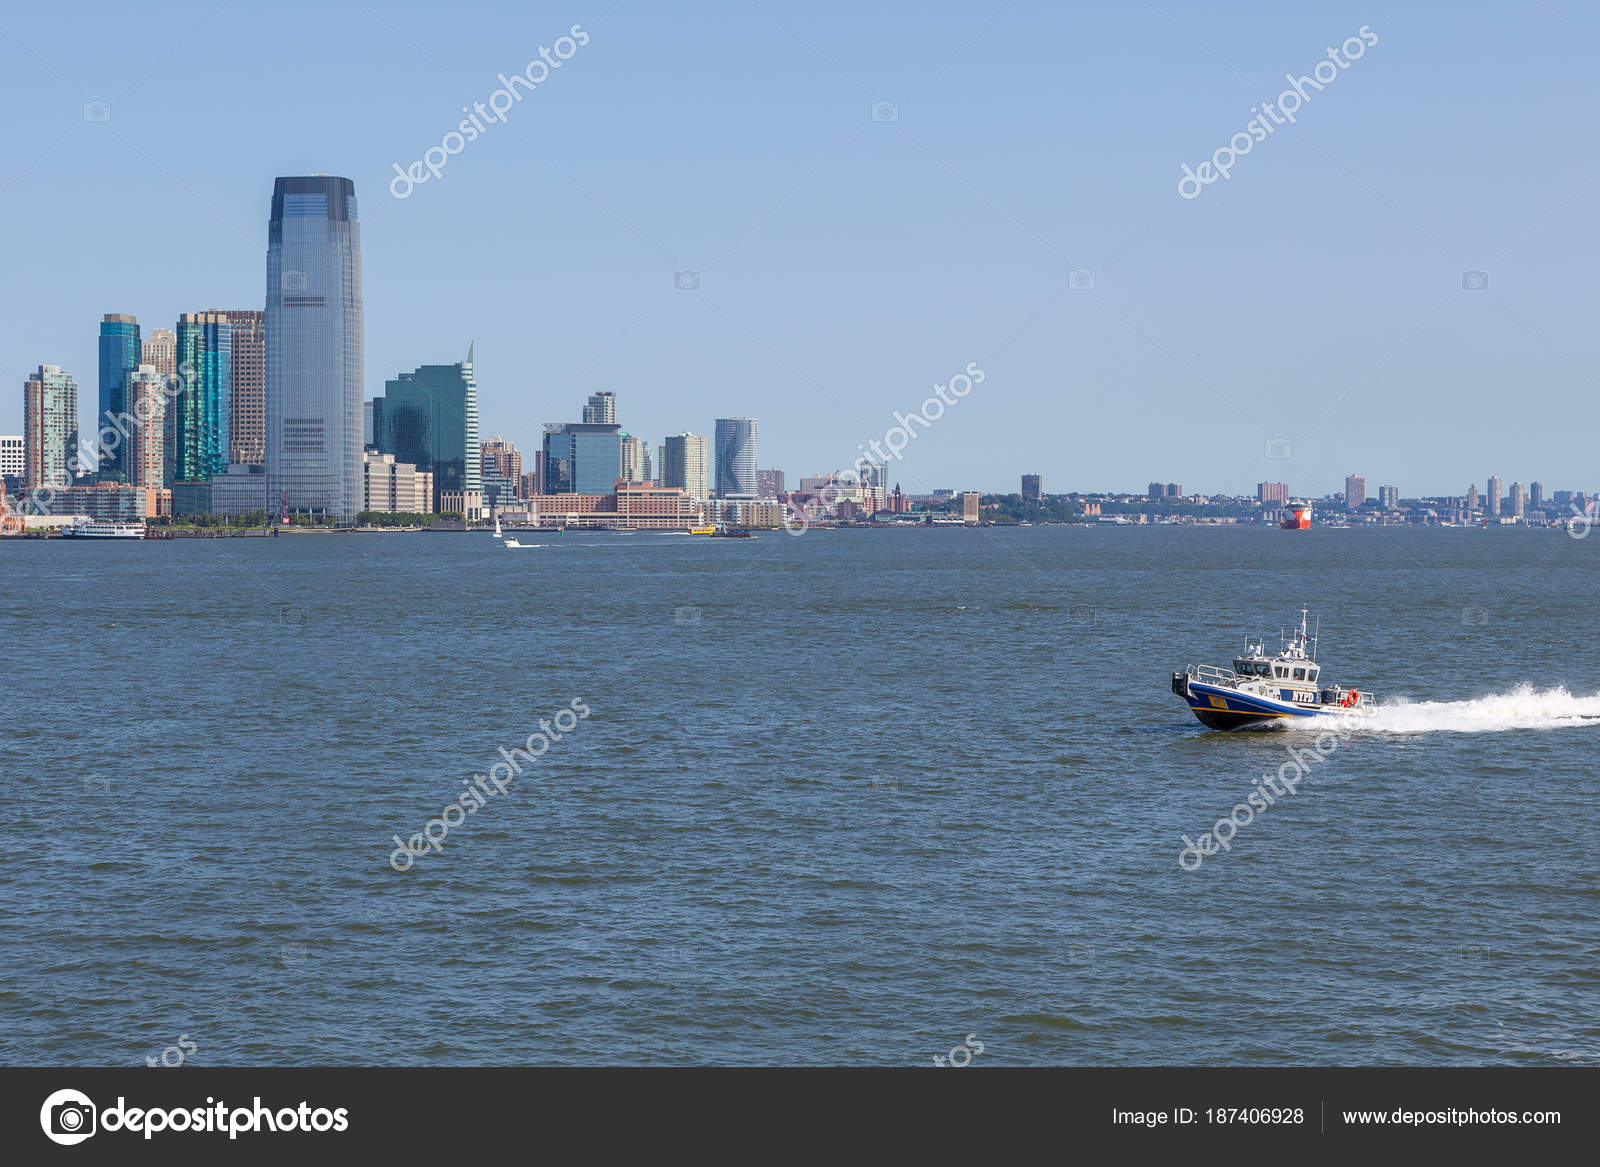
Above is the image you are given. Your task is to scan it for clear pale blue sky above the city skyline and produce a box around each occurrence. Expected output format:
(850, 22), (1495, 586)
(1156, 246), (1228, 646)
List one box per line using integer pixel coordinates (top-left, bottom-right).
(0, 0), (1600, 495)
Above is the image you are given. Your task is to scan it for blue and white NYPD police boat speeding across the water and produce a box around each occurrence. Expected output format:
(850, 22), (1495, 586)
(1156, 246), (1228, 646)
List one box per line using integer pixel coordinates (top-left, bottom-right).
(1173, 608), (1376, 730)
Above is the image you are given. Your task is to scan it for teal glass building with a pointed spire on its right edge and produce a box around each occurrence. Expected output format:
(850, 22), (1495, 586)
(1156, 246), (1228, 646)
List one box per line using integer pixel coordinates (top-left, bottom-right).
(373, 356), (483, 514)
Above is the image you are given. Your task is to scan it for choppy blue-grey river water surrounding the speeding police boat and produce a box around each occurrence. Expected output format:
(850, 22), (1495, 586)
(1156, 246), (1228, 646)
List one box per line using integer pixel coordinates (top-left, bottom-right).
(0, 528), (1600, 1065)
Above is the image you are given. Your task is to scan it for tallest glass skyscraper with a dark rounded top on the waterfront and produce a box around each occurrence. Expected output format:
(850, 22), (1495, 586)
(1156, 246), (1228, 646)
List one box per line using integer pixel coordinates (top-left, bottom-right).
(266, 174), (364, 522)
